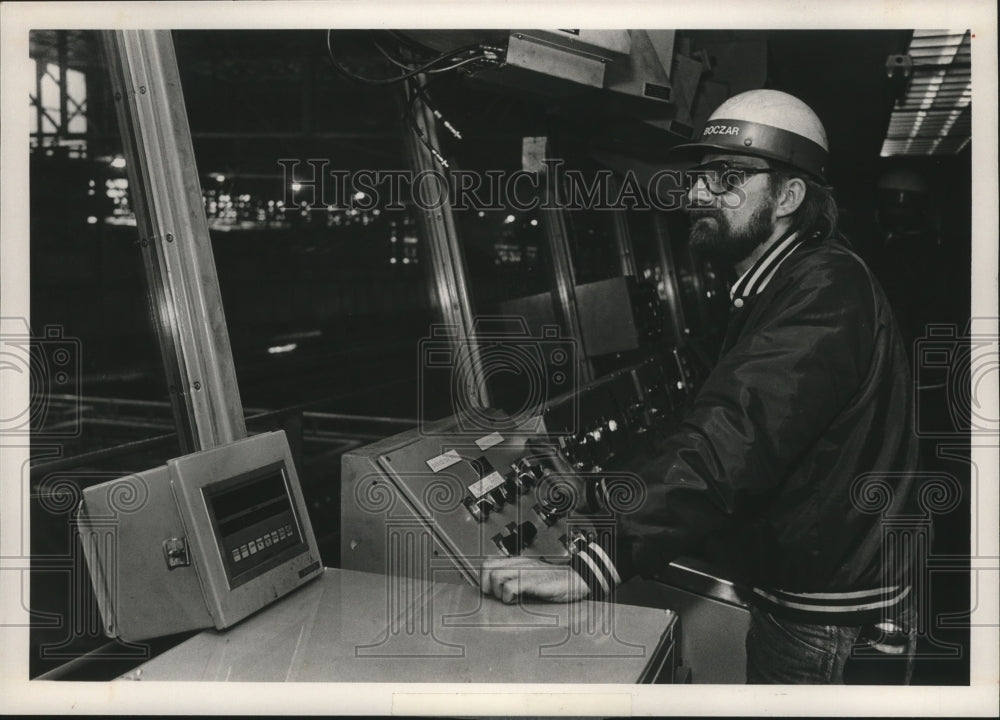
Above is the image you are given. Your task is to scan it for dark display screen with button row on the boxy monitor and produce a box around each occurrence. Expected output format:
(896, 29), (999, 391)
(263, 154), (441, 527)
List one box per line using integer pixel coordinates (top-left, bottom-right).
(202, 462), (307, 588)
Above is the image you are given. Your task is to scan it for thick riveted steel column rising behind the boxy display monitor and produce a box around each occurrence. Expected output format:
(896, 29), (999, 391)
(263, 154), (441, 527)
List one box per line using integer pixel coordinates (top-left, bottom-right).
(102, 30), (246, 451)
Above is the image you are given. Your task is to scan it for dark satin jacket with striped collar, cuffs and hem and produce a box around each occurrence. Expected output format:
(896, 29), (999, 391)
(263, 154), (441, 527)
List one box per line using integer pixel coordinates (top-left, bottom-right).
(574, 232), (918, 624)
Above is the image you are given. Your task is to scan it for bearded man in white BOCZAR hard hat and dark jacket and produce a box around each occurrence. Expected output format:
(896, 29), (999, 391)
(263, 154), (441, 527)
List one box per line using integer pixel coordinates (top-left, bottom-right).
(481, 90), (917, 683)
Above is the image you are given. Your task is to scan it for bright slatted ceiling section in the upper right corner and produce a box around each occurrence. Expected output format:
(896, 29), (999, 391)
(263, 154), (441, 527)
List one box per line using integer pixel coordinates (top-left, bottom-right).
(882, 30), (972, 157)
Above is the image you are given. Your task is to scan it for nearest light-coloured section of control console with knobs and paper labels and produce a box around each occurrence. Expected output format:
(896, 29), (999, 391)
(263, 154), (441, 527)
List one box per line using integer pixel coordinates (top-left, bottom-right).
(341, 412), (583, 583)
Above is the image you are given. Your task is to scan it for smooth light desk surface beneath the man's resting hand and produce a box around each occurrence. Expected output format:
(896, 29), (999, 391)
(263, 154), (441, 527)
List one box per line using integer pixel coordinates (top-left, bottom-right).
(122, 568), (677, 683)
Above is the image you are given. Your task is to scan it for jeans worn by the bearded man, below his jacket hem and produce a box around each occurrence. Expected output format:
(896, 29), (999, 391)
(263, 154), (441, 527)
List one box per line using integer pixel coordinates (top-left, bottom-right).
(747, 608), (861, 685)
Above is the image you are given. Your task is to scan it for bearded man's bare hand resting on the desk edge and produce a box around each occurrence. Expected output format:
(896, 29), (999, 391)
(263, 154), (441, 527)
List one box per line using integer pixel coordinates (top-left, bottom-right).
(479, 557), (590, 605)
